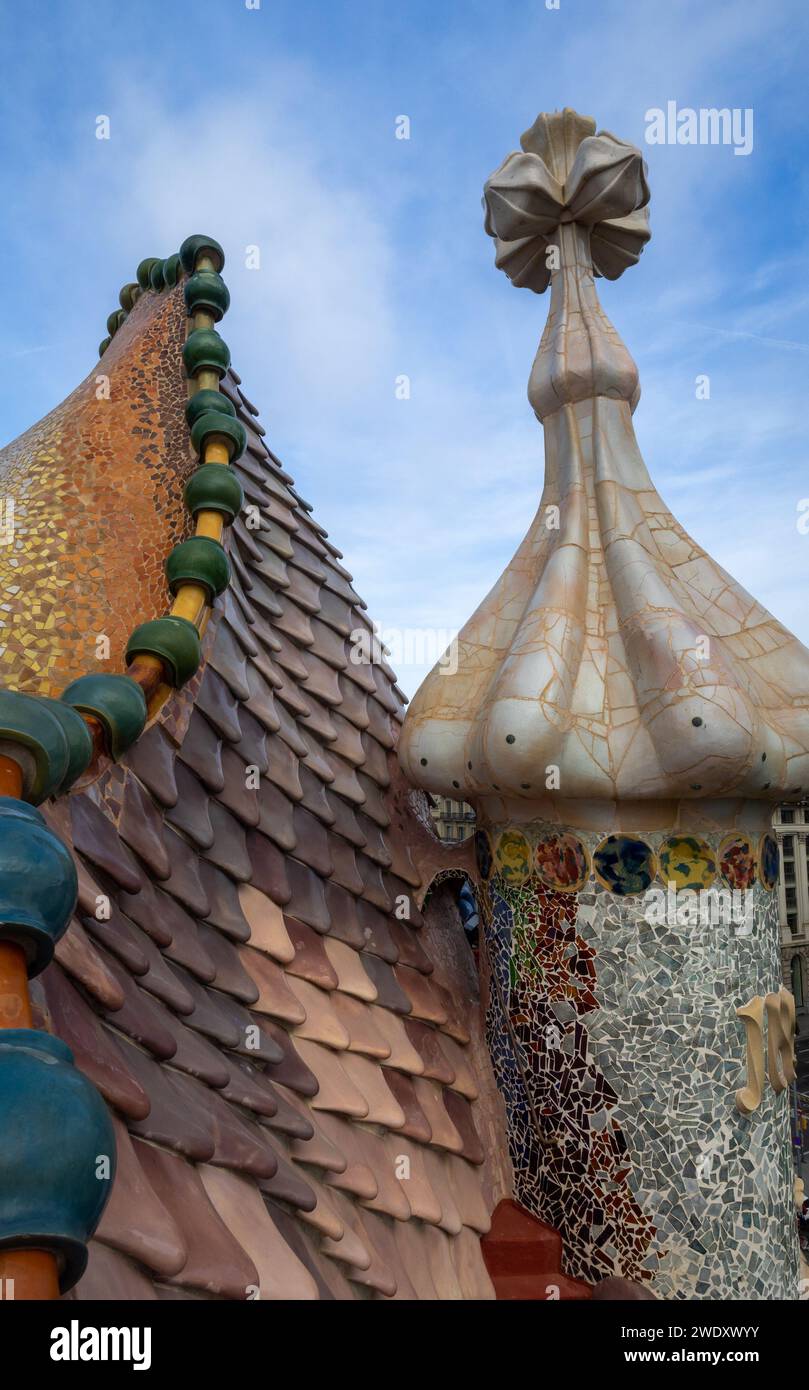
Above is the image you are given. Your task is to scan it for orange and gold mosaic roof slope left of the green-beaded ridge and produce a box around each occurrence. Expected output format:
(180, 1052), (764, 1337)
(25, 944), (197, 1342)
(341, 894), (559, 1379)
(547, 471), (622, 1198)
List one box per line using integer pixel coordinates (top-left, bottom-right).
(0, 286), (193, 695)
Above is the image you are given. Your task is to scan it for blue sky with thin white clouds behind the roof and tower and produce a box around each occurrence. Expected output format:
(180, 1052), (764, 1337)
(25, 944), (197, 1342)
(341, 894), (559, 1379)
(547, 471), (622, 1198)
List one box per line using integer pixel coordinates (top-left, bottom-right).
(0, 0), (809, 692)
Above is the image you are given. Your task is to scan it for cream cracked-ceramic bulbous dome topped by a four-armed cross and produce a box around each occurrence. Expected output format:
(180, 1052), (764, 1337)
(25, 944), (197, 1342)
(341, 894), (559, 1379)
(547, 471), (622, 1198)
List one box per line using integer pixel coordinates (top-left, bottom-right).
(400, 111), (809, 830)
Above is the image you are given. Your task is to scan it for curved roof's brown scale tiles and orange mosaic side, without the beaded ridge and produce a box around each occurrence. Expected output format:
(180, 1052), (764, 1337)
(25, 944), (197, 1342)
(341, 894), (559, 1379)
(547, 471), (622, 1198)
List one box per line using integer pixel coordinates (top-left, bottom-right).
(0, 262), (507, 1300)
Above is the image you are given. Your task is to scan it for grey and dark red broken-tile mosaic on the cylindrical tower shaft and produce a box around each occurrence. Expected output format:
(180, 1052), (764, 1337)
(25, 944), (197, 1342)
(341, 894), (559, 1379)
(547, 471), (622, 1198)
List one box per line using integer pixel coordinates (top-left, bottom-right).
(481, 824), (798, 1300)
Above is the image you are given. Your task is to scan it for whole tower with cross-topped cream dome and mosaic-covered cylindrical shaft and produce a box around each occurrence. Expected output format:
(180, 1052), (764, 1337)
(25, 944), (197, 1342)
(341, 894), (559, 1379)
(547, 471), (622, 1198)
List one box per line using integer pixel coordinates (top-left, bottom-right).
(399, 111), (809, 1300)
